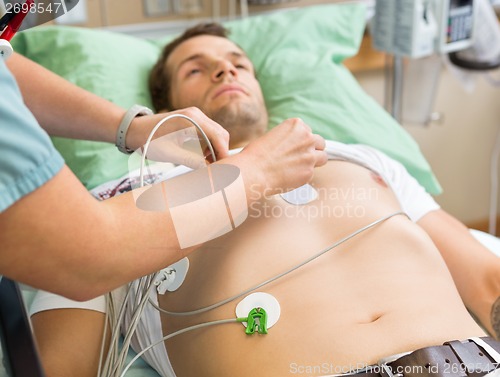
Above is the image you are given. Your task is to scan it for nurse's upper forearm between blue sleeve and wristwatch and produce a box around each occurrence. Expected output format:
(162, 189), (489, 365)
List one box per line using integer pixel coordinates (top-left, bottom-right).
(7, 53), (125, 143)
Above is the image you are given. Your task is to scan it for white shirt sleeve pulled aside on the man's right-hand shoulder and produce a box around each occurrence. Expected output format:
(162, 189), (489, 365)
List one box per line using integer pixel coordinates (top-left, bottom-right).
(326, 141), (440, 222)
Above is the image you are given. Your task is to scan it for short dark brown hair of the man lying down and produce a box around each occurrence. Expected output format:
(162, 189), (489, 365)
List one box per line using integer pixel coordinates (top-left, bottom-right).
(149, 23), (229, 111)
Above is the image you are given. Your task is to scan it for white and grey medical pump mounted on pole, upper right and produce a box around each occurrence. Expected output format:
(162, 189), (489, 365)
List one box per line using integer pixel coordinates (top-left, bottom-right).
(371, 0), (478, 122)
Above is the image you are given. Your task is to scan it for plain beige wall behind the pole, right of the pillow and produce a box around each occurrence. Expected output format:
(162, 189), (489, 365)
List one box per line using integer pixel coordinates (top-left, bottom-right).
(356, 64), (500, 227)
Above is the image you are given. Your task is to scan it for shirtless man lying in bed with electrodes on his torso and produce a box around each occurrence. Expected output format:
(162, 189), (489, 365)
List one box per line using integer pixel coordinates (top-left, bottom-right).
(33, 24), (500, 377)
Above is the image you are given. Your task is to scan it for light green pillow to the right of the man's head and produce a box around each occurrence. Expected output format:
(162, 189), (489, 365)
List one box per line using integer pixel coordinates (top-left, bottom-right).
(228, 3), (441, 194)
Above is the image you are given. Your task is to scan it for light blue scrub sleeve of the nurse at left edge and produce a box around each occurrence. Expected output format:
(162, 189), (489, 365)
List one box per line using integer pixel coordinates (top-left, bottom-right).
(0, 58), (64, 212)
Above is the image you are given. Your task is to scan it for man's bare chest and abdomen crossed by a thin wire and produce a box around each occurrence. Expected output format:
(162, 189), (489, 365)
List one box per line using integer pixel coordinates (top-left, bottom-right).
(159, 162), (482, 377)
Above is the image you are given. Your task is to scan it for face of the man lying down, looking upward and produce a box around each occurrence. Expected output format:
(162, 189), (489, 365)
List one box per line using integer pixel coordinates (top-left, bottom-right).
(166, 35), (268, 142)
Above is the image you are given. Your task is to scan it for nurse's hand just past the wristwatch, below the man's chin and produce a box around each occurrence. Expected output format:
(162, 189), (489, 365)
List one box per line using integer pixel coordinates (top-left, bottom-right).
(126, 107), (229, 164)
